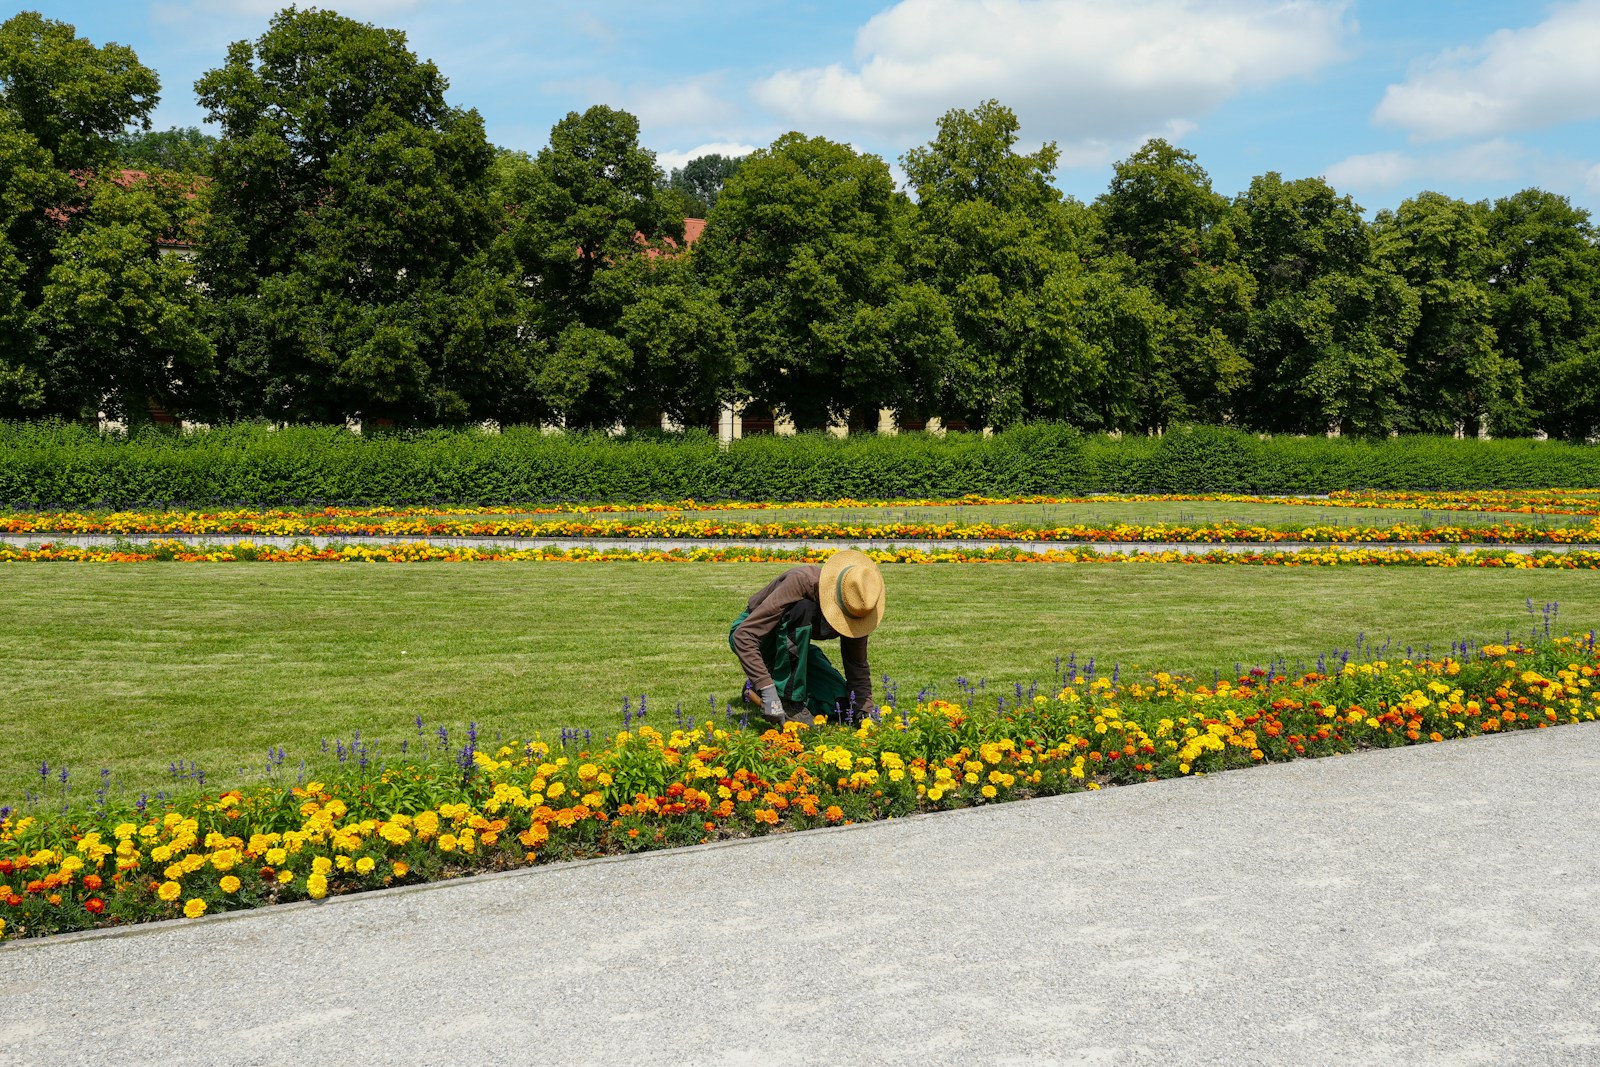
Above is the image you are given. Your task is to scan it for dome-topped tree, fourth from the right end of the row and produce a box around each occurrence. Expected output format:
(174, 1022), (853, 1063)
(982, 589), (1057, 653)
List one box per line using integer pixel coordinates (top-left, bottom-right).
(1094, 138), (1256, 426)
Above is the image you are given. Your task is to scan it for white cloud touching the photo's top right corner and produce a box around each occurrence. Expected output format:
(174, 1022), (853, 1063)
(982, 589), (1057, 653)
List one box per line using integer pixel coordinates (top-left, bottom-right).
(1373, 0), (1600, 141)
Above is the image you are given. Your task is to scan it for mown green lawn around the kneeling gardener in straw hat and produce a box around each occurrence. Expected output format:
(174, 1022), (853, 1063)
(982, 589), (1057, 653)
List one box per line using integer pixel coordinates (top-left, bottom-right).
(0, 563), (1600, 800)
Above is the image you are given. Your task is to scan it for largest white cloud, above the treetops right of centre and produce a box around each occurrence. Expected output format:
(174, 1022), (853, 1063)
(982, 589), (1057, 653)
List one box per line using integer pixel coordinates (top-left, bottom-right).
(754, 0), (1346, 162)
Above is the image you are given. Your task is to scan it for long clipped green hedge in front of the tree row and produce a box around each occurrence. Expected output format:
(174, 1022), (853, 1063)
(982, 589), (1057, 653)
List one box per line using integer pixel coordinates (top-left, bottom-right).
(0, 424), (1600, 509)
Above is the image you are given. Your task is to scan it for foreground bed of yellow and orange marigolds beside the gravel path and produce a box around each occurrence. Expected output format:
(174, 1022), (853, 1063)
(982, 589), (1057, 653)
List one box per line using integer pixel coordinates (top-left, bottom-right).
(0, 632), (1600, 937)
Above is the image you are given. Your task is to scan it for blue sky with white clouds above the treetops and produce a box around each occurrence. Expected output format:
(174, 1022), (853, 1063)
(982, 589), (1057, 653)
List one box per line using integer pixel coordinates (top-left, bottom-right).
(28, 0), (1600, 211)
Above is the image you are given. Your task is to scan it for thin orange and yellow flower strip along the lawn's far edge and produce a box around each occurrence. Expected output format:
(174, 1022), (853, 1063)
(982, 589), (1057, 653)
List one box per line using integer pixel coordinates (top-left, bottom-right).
(0, 539), (1600, 569)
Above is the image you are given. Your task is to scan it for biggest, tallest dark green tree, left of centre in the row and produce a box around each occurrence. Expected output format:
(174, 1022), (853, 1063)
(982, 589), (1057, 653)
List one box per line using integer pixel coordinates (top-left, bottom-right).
(195, 8), (533, 424)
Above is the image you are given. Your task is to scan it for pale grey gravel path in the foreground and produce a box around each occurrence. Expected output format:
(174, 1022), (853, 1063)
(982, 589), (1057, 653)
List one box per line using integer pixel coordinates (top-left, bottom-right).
(0, 725), (1600, 1067)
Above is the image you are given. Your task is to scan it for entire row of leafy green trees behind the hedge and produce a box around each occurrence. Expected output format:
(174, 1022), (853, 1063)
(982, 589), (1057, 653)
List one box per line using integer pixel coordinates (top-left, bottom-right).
(0, 6), (1600, 440)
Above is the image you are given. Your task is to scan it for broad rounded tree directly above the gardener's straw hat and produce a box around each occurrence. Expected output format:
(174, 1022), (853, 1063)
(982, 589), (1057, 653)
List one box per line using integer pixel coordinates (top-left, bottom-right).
(693, 133), (949, 429)
